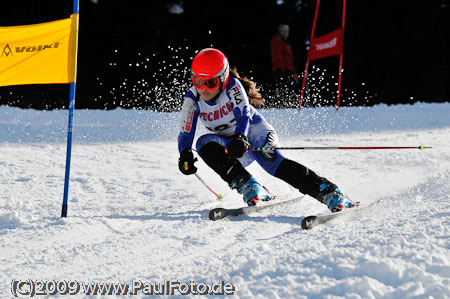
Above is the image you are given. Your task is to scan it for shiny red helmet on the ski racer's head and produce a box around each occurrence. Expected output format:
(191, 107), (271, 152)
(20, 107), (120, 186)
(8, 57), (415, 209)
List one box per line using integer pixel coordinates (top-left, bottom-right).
(191, 48), (230, 90)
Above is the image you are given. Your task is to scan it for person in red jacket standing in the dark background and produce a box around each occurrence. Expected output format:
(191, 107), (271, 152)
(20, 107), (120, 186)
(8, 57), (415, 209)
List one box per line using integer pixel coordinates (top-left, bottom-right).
(270, 24), (298, 82)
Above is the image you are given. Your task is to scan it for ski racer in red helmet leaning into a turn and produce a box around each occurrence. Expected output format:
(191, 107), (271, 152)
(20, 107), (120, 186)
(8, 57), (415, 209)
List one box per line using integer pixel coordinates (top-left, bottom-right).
(178, 48), (355, 212)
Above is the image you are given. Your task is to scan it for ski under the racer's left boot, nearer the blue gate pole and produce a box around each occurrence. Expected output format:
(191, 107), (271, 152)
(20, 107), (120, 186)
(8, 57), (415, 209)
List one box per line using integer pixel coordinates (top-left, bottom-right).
(209, 195), (306, 221)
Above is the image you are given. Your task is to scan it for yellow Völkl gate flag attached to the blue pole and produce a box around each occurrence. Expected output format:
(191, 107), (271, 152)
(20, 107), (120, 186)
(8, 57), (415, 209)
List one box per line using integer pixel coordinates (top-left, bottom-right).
(0, 14), (78, 86)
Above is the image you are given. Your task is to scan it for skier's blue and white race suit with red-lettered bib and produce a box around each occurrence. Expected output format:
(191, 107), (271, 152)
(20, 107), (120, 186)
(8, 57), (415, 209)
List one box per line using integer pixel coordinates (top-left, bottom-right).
(178, 77), (284, 175)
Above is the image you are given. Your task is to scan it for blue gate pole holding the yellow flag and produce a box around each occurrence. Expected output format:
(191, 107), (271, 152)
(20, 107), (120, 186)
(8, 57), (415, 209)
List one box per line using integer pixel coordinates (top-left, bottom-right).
(61, 0), (79, 217)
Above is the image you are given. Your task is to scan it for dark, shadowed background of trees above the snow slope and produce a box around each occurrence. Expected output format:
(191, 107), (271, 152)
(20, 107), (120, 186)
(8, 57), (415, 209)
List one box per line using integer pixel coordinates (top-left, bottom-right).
(0, 0), (450, 111)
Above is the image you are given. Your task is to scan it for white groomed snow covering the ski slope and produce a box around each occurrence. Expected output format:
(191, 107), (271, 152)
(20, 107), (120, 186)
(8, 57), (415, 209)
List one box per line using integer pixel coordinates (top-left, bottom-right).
(0, 103), (450, 298)
